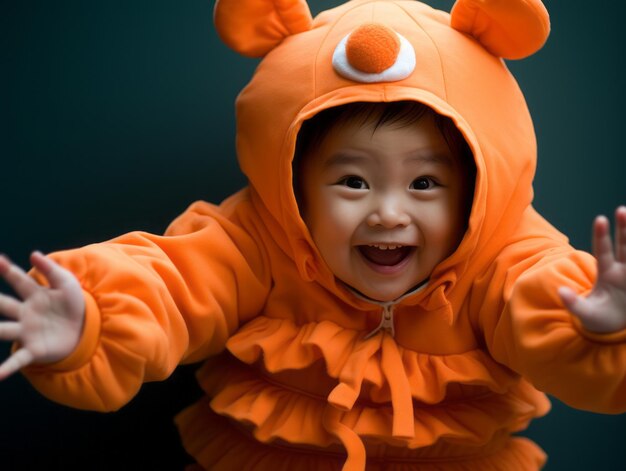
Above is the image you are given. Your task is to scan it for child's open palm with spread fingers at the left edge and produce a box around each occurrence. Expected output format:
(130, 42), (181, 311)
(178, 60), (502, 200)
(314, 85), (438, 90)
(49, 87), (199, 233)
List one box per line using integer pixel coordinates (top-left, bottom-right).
(0, 252), (85, 380)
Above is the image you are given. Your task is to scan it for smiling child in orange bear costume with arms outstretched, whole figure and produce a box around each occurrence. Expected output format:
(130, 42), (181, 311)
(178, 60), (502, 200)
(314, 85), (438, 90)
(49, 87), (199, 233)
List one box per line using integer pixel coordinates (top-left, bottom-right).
(0, 0), (626, 470)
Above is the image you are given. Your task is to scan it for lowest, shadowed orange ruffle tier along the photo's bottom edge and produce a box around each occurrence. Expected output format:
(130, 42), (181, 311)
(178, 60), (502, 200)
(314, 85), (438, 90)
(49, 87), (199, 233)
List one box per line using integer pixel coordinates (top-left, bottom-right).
(176, 398), (545, 471)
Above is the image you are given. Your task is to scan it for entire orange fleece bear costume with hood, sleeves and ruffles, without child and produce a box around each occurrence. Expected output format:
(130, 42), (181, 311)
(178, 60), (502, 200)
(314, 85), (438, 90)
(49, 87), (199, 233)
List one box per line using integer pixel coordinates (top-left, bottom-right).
(19, 0), (626, 471)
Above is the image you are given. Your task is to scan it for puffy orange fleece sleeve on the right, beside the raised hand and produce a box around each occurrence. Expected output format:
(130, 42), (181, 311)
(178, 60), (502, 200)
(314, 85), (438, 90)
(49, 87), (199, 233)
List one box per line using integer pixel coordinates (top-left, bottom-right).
(473, 238), (626, 413)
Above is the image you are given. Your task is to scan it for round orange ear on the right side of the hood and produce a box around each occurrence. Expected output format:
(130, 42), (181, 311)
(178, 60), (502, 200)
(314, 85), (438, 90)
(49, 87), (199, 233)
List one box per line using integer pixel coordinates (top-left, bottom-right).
(451, 0), (550, 59)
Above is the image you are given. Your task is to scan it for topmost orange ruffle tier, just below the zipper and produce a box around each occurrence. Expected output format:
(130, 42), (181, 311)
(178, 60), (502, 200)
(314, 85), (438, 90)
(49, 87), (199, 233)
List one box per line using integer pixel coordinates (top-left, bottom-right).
(227, 316), (518, 409)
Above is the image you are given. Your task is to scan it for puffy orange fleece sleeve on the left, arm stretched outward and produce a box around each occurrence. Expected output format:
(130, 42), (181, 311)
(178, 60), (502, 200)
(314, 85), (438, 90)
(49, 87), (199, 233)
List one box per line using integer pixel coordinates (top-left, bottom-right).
(24, 197), (270, 411)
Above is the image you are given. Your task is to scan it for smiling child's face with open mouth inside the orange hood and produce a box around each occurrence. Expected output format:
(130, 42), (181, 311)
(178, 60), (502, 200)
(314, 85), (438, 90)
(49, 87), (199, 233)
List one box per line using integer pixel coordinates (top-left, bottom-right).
(300, 116), (467, 301)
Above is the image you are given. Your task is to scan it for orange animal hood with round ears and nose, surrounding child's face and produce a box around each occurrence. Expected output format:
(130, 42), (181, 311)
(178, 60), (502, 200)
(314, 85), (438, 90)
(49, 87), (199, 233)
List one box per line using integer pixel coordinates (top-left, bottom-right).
(215, 0), (549, 314)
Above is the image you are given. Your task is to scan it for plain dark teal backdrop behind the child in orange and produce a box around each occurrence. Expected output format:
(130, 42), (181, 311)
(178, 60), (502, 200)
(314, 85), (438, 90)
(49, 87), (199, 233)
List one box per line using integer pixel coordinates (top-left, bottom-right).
(0, 0), (626, 470)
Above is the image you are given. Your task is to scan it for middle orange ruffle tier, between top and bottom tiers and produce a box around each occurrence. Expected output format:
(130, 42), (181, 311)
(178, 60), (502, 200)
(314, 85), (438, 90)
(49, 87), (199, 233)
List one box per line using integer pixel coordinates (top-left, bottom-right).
(198, 357), (549, 449)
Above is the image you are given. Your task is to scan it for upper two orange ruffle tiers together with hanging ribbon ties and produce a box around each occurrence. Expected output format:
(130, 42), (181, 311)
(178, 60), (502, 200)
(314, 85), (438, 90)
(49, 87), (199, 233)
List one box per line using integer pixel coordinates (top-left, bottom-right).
(183, 317), (549, 470)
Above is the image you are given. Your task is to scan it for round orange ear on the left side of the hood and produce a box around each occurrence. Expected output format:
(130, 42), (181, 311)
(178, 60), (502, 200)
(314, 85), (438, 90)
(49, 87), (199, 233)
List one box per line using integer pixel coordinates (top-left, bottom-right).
(213, 0), (313, 57)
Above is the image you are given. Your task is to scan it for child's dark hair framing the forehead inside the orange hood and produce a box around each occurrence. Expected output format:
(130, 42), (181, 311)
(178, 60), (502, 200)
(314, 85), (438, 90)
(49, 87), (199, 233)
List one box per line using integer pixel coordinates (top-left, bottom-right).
(292, 101), (476, 217)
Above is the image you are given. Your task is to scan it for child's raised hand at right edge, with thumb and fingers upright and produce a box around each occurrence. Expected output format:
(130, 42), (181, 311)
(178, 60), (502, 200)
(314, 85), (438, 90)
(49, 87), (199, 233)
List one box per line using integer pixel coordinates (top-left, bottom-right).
(559, 206), (626, 333)
